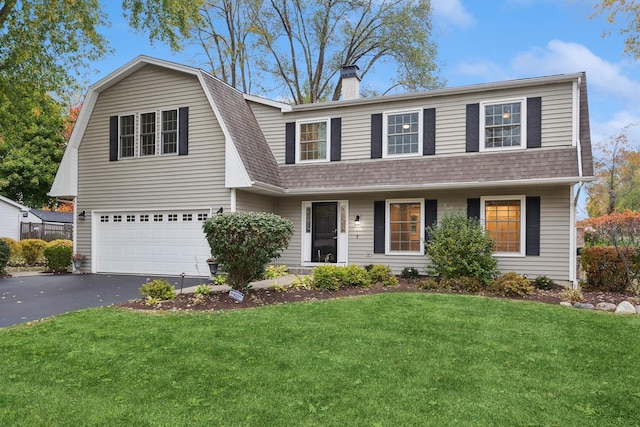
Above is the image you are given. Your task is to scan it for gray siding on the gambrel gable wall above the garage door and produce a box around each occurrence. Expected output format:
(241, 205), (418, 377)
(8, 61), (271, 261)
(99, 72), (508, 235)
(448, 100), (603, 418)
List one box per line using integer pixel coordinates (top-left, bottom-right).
(77, 65), (230, 268)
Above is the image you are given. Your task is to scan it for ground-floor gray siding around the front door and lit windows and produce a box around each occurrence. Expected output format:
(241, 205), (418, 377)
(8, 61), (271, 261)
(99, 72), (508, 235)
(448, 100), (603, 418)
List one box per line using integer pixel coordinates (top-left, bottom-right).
(276, 186), (571, 280)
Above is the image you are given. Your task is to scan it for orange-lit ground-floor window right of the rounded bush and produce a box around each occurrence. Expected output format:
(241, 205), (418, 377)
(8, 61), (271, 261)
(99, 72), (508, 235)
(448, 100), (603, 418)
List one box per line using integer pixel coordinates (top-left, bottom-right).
(480, 196), (525, 255)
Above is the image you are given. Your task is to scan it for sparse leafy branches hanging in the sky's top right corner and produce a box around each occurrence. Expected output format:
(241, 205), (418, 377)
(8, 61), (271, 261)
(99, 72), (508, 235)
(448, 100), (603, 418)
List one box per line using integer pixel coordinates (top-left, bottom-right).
(593, 0), (640, 59)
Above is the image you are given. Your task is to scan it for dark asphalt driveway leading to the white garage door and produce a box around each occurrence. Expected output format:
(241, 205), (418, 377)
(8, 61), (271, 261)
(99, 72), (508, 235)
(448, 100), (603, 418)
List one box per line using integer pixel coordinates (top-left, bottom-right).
(0, 274), (206, 327)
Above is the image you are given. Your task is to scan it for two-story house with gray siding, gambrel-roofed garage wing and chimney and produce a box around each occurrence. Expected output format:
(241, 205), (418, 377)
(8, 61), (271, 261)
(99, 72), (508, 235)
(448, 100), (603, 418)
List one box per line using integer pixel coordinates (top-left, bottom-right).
(50, 56), (593, 281)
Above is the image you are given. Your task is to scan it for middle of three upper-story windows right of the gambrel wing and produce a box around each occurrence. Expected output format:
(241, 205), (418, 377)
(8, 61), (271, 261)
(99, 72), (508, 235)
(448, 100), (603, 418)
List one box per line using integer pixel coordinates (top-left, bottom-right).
(383, 110), (422, 157)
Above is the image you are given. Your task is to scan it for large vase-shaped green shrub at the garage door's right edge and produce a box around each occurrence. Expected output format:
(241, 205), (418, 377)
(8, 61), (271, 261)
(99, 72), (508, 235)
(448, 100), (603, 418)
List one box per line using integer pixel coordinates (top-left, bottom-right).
(202, 212), (293, 290)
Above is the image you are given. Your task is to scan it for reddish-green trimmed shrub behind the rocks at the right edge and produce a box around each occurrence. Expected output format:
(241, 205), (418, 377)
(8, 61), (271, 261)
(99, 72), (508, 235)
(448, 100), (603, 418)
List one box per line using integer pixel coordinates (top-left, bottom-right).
(580, 246), (640, 292)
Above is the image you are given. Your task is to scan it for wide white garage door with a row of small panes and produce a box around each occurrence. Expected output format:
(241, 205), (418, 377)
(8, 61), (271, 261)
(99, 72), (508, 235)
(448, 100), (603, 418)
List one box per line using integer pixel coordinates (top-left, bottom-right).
(95, 210), (210, 276)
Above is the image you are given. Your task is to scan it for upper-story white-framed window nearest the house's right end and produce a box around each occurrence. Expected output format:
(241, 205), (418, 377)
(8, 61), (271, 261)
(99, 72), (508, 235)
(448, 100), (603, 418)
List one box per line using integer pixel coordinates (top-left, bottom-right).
(481, 100), (526, 149)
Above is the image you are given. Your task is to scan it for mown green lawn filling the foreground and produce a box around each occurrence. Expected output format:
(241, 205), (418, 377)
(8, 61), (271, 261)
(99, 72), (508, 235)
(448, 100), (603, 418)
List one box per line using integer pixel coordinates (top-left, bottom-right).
(0, 293), (640, 427)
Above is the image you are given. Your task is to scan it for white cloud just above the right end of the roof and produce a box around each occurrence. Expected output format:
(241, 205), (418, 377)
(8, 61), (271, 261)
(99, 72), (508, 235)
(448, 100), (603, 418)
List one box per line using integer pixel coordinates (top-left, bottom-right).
(511, 40), (640, 102)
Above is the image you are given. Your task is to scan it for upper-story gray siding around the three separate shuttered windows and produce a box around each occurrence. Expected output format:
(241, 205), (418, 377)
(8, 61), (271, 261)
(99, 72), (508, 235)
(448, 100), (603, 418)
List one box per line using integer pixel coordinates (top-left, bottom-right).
(250, 83), (575, 164)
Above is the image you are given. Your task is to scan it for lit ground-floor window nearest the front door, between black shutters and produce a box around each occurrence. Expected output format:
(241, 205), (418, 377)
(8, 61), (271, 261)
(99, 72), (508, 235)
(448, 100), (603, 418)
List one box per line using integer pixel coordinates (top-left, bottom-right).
(386, 200), (424, 254)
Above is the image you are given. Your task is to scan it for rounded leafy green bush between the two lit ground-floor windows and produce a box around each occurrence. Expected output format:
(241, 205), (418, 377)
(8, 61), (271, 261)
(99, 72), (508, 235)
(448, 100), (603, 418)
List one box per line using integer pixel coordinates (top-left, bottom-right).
(425, 213), (498, 285)
